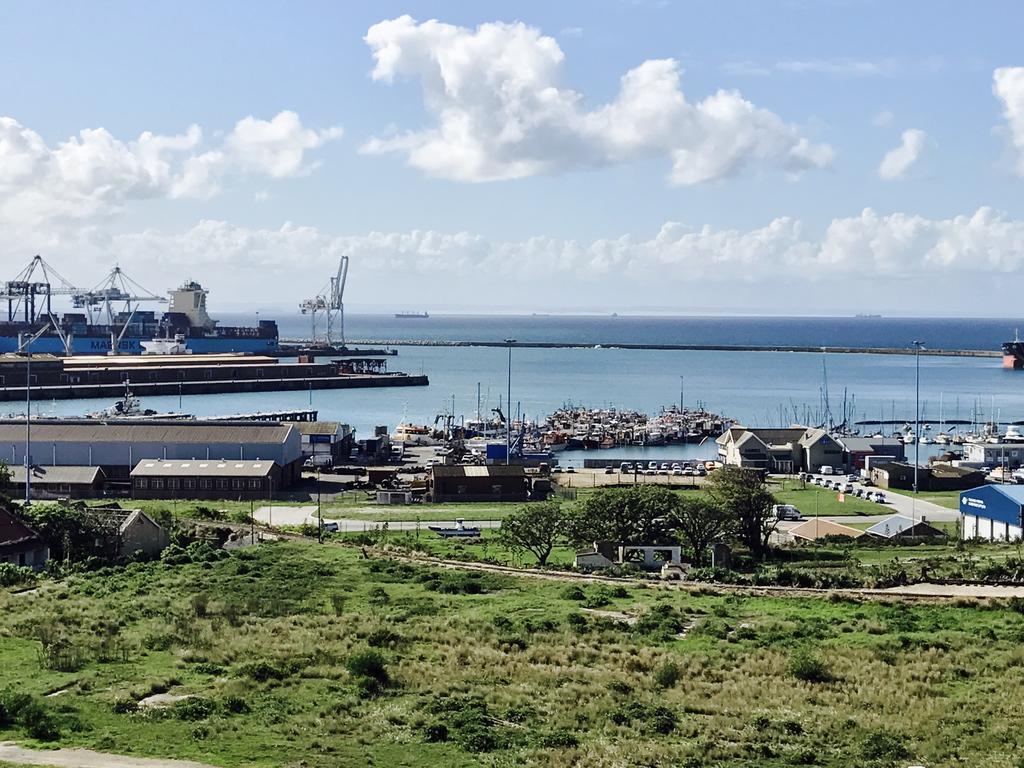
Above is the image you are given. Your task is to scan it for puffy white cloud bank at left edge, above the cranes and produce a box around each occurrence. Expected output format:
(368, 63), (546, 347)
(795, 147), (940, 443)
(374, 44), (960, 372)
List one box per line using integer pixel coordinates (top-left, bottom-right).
(0, 112), (340, 231)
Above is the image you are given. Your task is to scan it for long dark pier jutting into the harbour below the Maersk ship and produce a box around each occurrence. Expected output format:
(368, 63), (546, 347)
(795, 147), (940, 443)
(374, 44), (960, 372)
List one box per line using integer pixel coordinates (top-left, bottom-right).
(0, 354), (429, 400)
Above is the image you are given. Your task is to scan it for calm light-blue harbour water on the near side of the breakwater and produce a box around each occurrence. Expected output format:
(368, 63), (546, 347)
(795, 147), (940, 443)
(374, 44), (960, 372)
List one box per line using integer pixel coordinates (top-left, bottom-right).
(24, 346), (1024, 458)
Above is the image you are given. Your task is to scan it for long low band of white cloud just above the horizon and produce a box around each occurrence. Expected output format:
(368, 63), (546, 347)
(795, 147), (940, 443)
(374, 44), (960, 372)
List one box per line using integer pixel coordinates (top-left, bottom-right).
(29, 208), (1024, 304)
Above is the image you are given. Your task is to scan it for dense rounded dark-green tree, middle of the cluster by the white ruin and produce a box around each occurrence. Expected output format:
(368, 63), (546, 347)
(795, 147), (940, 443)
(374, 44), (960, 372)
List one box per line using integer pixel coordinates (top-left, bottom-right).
(570, 485), (679, 544)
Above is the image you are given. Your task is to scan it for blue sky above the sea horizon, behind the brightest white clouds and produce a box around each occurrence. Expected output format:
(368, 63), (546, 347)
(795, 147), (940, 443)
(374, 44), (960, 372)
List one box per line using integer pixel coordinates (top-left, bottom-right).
(0, 0), (1024, 314)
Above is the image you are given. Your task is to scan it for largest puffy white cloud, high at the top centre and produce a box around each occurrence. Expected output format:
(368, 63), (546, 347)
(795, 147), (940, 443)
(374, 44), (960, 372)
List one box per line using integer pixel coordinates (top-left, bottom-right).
(362, 15), (833, 184)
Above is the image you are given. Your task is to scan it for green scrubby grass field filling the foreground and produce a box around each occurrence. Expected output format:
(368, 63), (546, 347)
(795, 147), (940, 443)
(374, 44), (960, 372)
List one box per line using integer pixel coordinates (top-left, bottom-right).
(6, 543), (1024, 768)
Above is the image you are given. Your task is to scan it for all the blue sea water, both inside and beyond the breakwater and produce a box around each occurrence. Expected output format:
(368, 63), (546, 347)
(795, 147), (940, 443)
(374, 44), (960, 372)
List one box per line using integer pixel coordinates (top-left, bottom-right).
(22, 315), (1024, 468)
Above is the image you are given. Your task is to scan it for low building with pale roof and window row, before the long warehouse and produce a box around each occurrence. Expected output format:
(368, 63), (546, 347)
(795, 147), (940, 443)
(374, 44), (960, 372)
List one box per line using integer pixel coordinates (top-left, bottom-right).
(131, 459), (283, 500)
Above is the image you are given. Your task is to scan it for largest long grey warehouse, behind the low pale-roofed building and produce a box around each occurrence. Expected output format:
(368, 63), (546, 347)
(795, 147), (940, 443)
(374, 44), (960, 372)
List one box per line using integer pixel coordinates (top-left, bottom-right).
(0, 419), (302, 485)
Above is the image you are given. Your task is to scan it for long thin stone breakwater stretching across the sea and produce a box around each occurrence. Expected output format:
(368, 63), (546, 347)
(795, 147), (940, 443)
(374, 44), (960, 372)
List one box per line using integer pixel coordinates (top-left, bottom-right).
(292, 339), (1002, 358)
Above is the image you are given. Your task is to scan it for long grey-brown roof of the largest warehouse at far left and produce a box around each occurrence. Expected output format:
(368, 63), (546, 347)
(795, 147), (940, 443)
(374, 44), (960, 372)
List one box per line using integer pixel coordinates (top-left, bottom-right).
(0, 419), (292, 444)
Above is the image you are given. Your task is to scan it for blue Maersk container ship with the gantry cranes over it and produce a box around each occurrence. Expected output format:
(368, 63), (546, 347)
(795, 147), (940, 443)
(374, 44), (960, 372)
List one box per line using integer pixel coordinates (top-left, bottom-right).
(0, 256), (278, 355)
